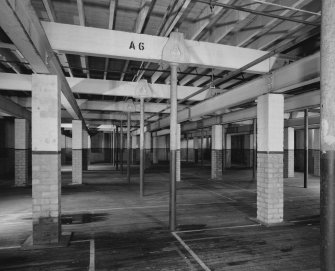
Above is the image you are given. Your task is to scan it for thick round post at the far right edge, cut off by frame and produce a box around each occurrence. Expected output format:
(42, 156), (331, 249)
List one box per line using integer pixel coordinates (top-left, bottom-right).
(320, 0), (335, 271)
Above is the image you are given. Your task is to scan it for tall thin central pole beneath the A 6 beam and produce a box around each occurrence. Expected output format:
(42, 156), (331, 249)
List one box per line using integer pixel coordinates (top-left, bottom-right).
(169, 64), (178, 231)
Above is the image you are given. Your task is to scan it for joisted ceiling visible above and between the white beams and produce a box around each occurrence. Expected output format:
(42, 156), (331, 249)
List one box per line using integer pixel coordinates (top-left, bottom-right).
(0, 0), (321, 132)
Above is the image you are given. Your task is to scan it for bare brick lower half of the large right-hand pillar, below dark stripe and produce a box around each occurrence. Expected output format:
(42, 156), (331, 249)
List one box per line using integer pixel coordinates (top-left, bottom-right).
(257, 152), (284, 224)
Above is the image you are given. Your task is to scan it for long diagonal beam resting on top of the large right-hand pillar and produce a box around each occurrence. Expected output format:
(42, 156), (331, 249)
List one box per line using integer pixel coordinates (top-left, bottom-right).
(149, 53), (320, 131)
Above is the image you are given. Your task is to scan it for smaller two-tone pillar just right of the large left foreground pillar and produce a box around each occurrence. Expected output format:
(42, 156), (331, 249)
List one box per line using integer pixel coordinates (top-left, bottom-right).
(72, 120), (83, 184)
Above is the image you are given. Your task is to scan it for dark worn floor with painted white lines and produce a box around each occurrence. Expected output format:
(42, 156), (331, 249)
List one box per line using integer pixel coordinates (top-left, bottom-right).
(0, 164), (320, 270)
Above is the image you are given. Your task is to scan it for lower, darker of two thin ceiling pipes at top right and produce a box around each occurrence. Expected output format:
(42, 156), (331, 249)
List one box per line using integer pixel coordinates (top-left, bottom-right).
(195, 0), (320, 26)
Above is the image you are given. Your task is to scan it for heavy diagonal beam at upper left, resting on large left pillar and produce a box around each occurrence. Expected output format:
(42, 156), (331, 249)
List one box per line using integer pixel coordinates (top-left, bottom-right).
(0, 1), (83, 124)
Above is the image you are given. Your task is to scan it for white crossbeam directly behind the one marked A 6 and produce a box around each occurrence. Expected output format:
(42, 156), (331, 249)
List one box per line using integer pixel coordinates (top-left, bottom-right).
(0, 73), (221, 101)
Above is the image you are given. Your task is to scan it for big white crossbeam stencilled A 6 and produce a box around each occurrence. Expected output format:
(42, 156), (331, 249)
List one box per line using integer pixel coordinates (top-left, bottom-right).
(43, 22), (276, 73)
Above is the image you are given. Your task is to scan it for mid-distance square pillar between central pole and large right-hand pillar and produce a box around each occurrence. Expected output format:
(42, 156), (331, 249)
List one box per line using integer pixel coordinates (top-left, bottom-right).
(211, 125), (223, 179)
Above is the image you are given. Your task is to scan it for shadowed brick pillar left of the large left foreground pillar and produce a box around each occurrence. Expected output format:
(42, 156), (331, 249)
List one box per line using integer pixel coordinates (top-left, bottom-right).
(14, 119), (31, 186)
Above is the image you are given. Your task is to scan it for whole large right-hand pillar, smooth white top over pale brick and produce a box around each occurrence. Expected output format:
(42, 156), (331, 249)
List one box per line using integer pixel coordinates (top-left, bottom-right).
(257, 94), (284, 225)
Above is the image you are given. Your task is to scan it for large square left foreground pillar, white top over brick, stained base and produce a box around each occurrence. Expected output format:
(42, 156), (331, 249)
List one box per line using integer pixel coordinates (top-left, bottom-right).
(31, 74), (61, 244)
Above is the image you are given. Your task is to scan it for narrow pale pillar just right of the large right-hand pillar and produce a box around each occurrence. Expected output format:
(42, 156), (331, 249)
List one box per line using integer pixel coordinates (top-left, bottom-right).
(284, 127), (294, 178)
